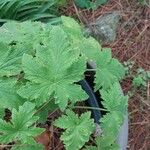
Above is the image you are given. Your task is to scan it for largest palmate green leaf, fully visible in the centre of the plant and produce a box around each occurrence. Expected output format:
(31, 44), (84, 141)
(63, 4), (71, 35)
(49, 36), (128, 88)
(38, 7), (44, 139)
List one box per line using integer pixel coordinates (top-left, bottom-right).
(18, 27), (87, 110)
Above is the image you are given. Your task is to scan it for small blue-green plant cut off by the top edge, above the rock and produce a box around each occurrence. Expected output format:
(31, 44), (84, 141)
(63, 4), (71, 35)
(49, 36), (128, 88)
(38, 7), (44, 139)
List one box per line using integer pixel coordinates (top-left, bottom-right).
(75, 0), (107, 9)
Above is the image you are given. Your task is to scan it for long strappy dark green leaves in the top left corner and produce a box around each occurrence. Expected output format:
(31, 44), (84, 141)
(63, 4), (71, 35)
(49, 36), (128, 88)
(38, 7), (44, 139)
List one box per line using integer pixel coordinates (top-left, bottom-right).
(0, 0), (66, 22)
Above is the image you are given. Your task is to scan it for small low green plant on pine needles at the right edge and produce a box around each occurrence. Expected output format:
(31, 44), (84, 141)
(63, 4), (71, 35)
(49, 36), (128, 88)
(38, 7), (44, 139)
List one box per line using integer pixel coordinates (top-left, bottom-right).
(132, 68), (150, 88)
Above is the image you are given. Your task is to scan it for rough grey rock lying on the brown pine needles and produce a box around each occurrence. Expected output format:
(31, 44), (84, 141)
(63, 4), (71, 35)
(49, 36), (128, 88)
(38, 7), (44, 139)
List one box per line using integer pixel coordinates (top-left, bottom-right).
(85, 11), (120, 44)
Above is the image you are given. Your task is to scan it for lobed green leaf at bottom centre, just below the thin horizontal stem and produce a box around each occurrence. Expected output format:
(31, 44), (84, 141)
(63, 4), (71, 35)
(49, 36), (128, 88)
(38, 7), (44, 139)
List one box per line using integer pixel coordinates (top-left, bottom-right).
(54, 110), (94, 150)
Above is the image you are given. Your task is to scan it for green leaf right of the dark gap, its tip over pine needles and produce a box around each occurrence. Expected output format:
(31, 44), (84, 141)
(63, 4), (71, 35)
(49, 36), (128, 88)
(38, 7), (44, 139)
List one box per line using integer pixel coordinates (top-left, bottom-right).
(95, 48), (125, 90)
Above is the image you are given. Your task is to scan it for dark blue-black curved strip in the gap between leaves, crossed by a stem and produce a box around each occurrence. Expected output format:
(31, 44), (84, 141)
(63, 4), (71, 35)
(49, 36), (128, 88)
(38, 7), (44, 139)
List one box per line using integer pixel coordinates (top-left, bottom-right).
(79, 79), (101, 124)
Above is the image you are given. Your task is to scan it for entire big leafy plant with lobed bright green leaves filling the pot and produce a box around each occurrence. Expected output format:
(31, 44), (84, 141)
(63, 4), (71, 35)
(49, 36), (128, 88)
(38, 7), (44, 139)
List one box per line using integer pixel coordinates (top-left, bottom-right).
(0, 16), (127, 150)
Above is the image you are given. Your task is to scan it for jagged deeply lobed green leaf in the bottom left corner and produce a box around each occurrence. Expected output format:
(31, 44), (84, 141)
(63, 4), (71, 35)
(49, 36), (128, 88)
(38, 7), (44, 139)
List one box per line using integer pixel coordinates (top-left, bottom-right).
(0, 102), (43, 144)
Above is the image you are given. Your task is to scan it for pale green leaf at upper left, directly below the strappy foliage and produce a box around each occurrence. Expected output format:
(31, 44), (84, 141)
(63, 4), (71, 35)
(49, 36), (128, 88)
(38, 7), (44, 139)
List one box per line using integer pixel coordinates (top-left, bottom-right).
(0, 21), (44, 46)
